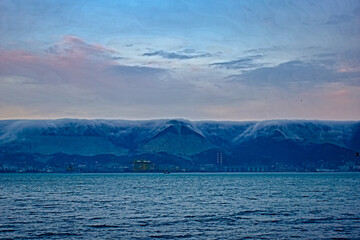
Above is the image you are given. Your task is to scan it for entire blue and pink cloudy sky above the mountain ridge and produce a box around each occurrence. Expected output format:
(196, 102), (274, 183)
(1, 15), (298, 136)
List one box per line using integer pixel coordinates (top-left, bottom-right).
(0, 0), (360, 121)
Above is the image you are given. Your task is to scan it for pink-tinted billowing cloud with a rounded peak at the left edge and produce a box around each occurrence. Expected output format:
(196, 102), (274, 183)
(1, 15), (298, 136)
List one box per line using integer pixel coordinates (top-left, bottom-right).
(0, 36), (122, 87)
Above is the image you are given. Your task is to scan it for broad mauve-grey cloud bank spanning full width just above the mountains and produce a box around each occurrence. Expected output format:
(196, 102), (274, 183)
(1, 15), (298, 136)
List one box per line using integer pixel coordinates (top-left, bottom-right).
(0, 43), (360, 120)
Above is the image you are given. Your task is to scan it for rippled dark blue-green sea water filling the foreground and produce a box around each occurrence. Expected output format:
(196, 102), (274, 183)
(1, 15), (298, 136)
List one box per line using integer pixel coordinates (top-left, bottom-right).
(0, 173), (360, 239)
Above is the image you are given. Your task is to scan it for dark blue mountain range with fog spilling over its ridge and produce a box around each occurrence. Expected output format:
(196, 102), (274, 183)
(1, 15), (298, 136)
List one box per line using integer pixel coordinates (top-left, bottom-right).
(0, 119), (360, 172)
